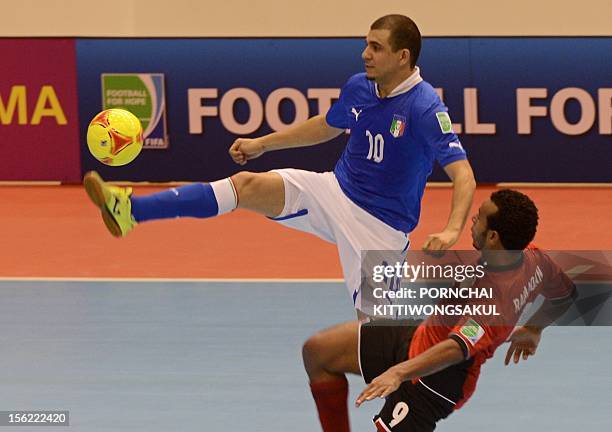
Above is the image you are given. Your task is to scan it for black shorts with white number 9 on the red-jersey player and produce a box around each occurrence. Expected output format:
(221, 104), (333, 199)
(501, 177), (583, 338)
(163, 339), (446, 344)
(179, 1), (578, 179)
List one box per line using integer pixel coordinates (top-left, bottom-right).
(359, 321), (454, 432)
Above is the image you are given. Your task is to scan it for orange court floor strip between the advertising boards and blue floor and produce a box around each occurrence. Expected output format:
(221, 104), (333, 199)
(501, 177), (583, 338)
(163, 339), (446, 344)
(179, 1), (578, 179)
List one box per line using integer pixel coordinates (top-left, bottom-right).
(0, 185), (612, 279)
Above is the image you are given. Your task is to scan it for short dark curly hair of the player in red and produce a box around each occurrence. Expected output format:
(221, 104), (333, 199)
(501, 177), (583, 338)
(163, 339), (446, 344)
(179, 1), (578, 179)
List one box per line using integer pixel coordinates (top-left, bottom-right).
(487, 189), (538, 250)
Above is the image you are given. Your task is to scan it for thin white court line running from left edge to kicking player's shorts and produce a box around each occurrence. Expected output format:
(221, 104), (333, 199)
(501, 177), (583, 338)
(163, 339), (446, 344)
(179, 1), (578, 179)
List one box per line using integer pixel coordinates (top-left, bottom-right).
(0, 276), (344, 283)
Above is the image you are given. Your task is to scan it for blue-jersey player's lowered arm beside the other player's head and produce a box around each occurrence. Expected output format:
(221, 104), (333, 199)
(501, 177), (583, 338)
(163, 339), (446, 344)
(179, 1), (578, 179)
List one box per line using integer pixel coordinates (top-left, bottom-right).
(423, 160), (476, 251)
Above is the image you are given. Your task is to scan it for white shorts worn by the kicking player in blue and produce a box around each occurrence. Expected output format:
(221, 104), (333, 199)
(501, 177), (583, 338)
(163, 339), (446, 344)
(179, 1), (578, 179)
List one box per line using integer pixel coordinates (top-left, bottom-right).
(272, 168), (410, 309)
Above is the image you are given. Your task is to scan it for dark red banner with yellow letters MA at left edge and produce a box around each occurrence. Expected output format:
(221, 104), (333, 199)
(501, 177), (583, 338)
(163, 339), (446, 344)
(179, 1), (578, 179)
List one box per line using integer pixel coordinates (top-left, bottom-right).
(0, 39), (81, 182)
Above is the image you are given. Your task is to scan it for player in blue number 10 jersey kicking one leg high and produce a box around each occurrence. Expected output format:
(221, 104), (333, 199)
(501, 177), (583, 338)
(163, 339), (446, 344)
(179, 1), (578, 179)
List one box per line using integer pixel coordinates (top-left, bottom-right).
(84, 15), (475, 310)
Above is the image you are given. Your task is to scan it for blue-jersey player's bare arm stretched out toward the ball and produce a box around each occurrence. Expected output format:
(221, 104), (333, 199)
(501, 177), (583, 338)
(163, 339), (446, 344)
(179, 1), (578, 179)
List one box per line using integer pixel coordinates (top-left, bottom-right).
(229, 114), (344, 165)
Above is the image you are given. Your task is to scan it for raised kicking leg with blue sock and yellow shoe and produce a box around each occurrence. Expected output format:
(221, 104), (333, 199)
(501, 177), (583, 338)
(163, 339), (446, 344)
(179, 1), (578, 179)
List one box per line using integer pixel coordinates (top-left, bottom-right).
(83, 172), (285, 237)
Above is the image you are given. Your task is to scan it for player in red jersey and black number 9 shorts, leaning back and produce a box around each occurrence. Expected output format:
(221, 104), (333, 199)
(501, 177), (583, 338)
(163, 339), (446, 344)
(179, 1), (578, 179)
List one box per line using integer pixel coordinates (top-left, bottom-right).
(303, 190), (575, 432)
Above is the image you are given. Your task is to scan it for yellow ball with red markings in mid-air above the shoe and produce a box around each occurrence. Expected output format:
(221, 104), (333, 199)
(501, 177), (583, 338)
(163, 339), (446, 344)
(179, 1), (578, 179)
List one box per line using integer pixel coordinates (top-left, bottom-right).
(87, 108), (142, 166)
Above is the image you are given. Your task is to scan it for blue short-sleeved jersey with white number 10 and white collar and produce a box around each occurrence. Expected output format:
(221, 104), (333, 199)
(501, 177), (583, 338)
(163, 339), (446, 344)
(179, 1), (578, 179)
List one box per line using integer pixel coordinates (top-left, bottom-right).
(326, 69), (466, 233)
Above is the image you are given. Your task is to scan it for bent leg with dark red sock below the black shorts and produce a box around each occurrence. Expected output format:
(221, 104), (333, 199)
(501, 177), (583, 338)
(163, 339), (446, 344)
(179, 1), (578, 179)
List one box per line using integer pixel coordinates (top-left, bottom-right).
(302, 321), (361, 432)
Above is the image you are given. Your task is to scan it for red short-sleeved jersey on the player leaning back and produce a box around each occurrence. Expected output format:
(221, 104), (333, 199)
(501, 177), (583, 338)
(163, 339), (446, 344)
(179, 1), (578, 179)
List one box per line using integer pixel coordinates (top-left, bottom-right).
(409, 248), (575, 409)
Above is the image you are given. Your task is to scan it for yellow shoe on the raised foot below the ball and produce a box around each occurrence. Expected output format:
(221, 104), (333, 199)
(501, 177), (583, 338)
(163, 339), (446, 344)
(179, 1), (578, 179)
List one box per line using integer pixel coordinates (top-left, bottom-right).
(83, 171), (137, 237)
